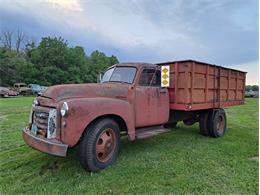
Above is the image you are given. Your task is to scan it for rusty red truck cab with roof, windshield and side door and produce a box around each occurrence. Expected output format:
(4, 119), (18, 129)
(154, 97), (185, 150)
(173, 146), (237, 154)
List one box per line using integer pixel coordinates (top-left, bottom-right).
(101, 64), (169, 129)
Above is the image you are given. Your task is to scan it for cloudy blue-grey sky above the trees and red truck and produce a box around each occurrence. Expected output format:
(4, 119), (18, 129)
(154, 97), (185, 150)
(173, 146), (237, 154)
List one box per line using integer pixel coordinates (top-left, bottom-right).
(0, 0), (259, 84)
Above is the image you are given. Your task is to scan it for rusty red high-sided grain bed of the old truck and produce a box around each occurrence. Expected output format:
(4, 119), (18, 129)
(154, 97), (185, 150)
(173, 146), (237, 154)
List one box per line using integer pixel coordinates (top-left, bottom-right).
(158, 60), (246, 111)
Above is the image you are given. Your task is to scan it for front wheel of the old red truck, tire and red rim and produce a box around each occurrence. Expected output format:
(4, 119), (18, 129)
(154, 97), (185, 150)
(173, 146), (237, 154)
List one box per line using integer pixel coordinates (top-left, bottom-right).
(79, 118), (120, 172)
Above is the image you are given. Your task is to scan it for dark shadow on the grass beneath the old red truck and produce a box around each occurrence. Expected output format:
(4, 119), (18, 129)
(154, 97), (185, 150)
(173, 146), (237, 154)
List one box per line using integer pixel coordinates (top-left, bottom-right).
(23, 124), (213, 180)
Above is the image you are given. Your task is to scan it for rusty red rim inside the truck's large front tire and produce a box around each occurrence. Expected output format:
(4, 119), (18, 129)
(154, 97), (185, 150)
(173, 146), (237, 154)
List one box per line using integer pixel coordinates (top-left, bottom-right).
(96, 128), (116, 163)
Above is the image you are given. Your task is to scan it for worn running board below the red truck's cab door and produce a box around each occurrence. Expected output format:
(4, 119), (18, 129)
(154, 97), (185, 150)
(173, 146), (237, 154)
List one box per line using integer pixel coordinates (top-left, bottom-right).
(135, 126), (170, 139)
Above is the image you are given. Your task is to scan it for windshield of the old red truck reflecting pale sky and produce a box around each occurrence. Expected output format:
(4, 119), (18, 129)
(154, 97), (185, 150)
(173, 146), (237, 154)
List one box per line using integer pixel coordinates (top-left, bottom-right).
(101, 67), (136, 84)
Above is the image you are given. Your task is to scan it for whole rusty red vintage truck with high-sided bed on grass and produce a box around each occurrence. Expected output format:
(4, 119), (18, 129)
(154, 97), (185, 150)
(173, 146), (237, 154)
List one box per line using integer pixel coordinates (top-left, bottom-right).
(23, 60), (246, 172)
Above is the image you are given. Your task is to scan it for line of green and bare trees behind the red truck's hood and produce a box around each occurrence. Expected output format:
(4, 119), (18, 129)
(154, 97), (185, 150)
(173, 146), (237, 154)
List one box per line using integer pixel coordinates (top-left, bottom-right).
(0, 30), (118, 86)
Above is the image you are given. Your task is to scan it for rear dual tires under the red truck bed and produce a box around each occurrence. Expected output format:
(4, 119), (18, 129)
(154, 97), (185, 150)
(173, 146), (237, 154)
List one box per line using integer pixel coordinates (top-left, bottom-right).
(200, 109), (227, 138)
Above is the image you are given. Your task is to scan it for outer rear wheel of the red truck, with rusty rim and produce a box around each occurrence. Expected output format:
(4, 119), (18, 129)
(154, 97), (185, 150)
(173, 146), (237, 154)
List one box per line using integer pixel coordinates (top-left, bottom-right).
(208, 109), (227, 138)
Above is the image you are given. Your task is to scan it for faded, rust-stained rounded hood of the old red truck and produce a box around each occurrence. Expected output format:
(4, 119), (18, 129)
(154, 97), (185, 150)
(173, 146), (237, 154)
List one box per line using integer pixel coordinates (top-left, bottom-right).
(41, 83), (128, 102)
